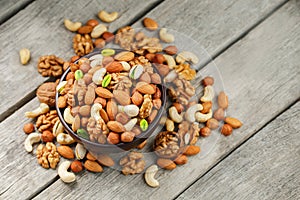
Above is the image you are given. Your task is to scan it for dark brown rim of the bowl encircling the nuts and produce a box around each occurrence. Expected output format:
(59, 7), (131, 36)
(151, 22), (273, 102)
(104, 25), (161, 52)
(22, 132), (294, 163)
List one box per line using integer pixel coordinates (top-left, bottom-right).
(55, 48), (167, 150)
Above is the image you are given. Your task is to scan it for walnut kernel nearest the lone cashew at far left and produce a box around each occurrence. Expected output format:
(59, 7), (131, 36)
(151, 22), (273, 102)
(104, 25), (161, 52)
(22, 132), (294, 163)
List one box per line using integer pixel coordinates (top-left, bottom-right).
(37, 55), (64, 77)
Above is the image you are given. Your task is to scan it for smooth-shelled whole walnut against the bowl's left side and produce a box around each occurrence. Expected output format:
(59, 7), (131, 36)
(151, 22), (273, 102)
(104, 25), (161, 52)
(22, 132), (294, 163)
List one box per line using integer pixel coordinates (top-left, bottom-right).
(36, 82), (56, 107)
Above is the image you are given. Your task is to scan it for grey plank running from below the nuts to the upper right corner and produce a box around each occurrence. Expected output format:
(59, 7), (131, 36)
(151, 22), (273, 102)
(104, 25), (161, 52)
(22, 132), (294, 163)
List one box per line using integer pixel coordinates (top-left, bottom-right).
(32, 1), (300, 199)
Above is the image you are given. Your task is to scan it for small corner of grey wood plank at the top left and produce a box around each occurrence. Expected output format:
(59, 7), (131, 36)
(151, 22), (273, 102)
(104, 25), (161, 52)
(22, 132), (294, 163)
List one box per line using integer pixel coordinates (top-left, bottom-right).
(0, 0), (33, 24)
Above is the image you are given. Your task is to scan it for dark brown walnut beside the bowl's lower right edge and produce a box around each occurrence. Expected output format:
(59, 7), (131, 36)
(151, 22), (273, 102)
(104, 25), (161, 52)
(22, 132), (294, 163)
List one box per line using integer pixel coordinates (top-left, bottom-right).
(154, 131), (183, 158)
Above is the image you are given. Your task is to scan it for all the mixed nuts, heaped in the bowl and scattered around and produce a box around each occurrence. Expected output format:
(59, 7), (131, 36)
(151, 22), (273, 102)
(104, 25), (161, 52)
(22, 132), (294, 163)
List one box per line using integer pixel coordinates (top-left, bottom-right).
(20, 11), (242, 187)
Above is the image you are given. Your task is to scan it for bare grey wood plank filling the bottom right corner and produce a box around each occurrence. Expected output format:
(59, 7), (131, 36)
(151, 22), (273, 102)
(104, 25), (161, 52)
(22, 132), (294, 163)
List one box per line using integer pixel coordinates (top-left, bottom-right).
(178, 102), (300, 200)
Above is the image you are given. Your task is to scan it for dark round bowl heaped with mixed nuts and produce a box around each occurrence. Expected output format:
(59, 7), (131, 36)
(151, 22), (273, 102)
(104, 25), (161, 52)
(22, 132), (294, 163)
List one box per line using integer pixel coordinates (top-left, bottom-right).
(56, 49), (166, 152)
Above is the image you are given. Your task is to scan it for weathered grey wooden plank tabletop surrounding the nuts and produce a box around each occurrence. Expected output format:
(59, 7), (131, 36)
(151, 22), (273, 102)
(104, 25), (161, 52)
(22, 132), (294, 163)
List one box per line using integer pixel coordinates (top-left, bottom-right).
(0, 0), (300, 199)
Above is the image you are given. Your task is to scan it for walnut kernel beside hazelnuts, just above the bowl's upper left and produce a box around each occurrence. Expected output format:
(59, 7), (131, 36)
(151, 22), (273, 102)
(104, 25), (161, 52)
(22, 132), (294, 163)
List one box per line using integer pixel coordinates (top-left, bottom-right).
(73, 34), (94, 56)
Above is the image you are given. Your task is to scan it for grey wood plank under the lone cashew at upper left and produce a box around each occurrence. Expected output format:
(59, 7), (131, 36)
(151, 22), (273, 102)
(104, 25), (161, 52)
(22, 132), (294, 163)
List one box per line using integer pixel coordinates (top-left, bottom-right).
(0, 0), (160, 121)
